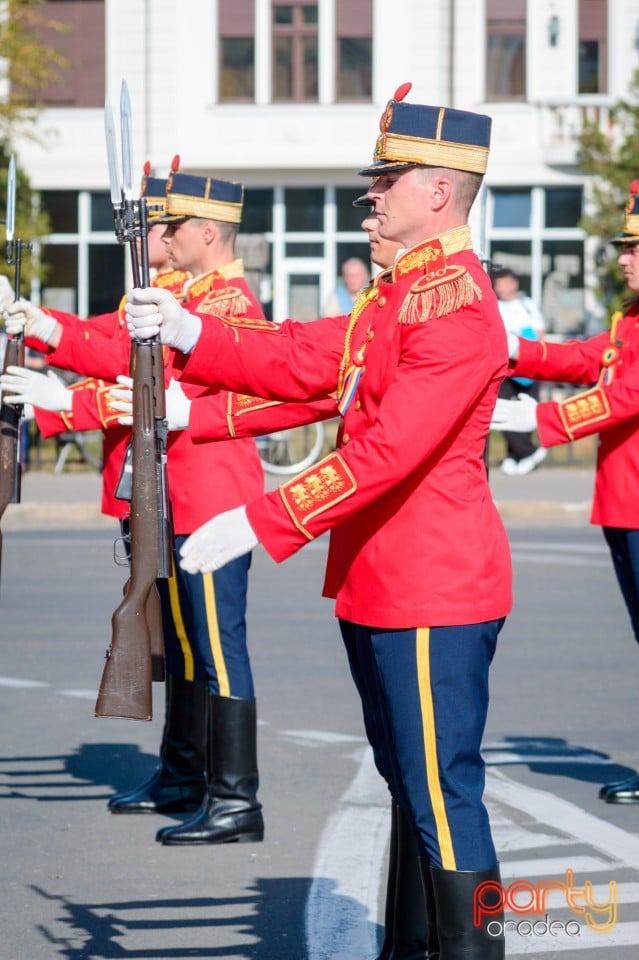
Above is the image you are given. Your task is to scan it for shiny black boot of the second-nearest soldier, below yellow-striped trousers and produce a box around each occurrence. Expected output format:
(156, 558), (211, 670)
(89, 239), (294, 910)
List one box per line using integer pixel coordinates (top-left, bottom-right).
(156, 696), (264, 846)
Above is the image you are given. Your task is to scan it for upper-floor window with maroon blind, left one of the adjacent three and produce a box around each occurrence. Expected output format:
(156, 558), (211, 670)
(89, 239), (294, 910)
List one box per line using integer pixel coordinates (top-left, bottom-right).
(219, 0), (255, 102)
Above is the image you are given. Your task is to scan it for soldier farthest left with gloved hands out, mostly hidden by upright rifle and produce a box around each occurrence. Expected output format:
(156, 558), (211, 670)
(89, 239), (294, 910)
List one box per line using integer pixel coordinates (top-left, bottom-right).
(4, 174), (207, 832)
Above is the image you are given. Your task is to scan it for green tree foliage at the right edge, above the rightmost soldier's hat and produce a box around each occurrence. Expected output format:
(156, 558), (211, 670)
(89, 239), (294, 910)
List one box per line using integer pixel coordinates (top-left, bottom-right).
(578, 71), (639, 313)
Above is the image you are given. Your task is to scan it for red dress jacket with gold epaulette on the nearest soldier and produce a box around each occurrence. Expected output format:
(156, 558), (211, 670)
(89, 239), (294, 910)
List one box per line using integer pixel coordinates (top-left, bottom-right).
(178, 227), (511, 629)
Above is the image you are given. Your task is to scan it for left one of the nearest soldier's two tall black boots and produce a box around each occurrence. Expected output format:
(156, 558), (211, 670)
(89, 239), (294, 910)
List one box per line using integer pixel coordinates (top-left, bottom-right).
(377, 804), (439, 960)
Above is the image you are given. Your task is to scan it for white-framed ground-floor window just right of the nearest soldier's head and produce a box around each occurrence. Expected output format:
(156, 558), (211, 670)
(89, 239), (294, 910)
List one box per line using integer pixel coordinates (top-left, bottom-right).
(488, 186), (588, 336)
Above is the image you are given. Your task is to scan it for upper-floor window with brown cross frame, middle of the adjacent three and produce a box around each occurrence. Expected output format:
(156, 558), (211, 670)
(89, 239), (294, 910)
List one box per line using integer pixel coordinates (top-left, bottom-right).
(272, 0), (319, 102)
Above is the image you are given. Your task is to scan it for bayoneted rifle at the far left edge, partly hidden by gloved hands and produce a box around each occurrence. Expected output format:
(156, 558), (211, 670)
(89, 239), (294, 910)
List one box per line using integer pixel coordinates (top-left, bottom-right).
(0, 154), (31, 570)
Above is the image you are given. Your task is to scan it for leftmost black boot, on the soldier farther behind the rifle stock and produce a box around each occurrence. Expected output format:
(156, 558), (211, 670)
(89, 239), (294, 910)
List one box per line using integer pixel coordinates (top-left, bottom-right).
(108, 674), (208, 813)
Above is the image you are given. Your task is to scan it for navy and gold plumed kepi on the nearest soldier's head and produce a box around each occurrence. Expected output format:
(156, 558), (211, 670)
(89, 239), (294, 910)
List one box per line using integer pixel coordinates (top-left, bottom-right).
(359, 83), (492, 177)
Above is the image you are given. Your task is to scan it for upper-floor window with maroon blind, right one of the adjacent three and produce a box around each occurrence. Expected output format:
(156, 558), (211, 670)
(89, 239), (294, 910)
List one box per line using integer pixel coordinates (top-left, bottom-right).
(335, 0), (373, 100)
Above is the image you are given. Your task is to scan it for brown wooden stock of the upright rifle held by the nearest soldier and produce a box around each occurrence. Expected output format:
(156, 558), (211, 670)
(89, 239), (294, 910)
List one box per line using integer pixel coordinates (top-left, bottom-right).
(95, 342), (164, 720)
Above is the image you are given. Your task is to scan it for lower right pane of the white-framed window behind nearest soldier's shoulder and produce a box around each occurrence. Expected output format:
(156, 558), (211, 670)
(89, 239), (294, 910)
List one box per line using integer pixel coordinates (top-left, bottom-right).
(541, 240), (586, 335)
